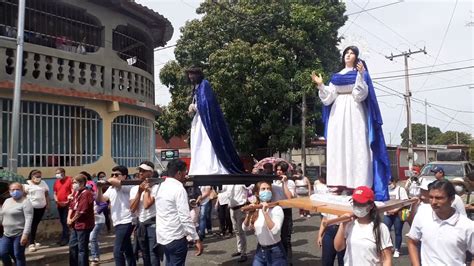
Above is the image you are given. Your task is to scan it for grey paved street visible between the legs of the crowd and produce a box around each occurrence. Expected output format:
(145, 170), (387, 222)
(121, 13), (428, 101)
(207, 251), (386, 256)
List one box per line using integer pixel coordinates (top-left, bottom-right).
(50, 210), (410, 266)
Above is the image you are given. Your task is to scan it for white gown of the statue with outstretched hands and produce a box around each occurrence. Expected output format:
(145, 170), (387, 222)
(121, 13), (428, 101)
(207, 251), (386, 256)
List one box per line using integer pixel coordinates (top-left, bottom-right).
(319, 68), (373, 189)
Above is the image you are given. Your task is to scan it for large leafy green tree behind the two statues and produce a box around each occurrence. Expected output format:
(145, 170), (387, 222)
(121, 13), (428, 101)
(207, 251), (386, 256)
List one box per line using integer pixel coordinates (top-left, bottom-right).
(157, 0), (347, 152)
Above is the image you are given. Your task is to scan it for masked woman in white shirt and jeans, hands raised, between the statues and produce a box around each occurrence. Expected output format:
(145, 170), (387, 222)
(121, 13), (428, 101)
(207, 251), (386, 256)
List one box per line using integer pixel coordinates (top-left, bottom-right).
(242, 181), (287, 266)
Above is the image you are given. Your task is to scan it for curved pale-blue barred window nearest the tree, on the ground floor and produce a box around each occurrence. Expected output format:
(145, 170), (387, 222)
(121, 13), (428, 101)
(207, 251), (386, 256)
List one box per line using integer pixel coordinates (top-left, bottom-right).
(112, 115), (154, 167)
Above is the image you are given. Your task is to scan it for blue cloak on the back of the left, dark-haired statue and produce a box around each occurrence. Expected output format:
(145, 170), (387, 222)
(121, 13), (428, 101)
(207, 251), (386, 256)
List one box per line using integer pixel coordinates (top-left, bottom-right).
(196, 80), (243, 174)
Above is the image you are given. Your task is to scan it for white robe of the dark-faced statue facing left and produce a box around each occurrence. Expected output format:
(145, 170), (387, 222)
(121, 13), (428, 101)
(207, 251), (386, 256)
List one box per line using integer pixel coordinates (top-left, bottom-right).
(188, 103), (229, 175)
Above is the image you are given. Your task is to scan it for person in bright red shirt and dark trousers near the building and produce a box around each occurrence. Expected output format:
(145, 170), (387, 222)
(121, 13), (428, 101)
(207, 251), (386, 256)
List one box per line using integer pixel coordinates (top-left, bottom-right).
(53, 168), (72, 246)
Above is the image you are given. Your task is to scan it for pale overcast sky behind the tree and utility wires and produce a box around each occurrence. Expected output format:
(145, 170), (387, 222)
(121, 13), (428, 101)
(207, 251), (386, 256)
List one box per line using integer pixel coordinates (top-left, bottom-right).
(137, 0), (474, 144)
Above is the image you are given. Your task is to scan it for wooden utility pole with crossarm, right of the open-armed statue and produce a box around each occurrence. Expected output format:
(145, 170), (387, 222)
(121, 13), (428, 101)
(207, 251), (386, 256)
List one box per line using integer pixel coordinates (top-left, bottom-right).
(385, 48), (427, 171)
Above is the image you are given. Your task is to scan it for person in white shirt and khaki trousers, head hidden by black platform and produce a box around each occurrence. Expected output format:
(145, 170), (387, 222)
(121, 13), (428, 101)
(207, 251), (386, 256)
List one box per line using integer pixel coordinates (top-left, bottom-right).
(227, 185), (248, 262)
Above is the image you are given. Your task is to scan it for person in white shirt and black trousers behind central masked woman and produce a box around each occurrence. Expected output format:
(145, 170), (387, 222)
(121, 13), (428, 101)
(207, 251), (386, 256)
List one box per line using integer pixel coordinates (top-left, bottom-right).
(272, 162), (296, 265)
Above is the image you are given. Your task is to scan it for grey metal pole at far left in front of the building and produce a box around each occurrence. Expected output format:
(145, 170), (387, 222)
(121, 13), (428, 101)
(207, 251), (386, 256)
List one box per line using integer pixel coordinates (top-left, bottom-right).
(8, 0), (25, 173)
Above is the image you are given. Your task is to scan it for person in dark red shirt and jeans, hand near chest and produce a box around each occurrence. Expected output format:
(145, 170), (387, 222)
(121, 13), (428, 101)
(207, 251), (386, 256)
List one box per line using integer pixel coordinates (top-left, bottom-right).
(67, 174), (95, 266)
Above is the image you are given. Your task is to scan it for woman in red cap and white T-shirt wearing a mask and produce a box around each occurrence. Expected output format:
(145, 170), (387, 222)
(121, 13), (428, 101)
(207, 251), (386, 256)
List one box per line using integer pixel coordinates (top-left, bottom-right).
(334, 186), (392, 266)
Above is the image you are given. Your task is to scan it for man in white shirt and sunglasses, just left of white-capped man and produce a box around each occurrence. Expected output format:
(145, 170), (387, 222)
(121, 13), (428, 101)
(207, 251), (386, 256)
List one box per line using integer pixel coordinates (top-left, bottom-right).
(97, 165), (137, 266)
